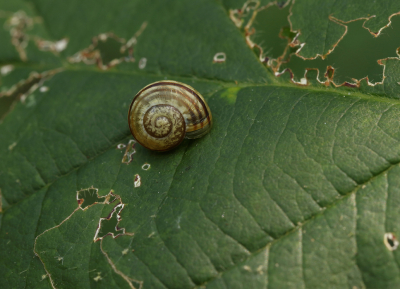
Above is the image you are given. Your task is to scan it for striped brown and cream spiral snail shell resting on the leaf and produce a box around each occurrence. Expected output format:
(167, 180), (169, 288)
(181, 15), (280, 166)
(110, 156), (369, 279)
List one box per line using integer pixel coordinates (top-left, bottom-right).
(128, 80), (212, 151)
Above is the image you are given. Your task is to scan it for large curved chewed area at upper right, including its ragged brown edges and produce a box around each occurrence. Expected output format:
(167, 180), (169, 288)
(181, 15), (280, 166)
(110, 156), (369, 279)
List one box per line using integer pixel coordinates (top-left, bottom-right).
(230, 0), (398, 88)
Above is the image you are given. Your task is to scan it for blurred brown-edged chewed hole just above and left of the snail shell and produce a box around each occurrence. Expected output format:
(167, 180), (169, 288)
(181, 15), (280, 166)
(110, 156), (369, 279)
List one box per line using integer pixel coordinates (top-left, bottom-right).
(68, 22), (147, 70)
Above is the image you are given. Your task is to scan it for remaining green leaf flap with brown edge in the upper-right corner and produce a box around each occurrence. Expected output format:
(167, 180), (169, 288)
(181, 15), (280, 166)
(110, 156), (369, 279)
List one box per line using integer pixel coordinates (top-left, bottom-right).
(289, 0), (400, 58)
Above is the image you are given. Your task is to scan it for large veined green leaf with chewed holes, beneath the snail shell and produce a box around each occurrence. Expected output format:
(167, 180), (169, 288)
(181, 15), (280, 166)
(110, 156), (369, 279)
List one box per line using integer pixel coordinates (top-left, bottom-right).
(0, 0), (400, 289)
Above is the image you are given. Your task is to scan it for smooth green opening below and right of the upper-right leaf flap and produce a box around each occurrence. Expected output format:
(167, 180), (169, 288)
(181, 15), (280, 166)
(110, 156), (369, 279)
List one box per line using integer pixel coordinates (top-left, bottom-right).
(281, 17), (400, 84)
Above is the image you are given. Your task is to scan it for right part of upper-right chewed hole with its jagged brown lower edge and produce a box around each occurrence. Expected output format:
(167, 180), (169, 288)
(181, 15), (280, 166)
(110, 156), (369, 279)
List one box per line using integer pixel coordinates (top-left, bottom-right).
(277, 17), (400, 90)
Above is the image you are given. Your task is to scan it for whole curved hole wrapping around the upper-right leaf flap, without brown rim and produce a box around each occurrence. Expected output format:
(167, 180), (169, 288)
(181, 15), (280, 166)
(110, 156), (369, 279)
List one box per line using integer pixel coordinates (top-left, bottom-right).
(247, 5), (400, 85)
